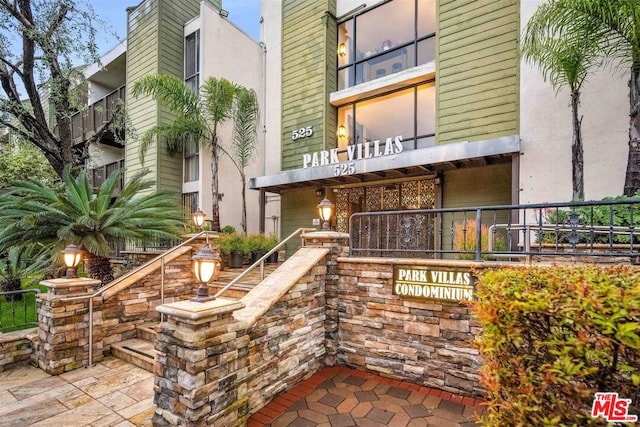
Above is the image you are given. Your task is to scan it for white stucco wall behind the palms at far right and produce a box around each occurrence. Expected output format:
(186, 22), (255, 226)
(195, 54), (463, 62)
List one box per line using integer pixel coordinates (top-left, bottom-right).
(520, 0), (629, 203)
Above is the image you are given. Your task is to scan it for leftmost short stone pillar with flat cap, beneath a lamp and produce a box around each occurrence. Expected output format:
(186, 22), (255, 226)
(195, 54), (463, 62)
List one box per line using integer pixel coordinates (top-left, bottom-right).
(35, 277), (103, 375)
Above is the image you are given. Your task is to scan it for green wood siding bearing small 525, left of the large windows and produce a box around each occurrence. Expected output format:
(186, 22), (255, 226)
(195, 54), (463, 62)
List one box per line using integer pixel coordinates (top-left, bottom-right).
(282, 0), (337, 170)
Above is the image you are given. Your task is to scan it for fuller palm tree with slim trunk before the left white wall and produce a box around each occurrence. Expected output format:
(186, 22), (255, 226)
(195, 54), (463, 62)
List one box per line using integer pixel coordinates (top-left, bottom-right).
(133, 74), (258, 231)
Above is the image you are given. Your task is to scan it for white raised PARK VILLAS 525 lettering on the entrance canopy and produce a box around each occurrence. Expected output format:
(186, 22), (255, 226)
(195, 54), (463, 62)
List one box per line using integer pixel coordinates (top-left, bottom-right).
(302, 136), (404, 176)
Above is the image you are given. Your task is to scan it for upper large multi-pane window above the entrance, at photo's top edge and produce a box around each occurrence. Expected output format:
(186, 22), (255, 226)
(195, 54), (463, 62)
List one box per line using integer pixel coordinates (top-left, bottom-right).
(338, 0), (436, 90)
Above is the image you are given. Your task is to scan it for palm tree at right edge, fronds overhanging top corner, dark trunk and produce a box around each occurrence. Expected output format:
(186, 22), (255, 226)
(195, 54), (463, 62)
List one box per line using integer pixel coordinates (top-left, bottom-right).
(520, 0), (640, 196)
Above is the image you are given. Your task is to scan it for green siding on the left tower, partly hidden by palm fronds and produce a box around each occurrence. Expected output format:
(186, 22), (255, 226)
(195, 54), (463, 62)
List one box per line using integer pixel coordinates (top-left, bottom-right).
(126, 0), (202, 193)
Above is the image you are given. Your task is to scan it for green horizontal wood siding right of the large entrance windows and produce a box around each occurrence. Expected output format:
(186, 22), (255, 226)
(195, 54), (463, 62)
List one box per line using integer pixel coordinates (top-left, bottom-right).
(436, 0), (520, 144)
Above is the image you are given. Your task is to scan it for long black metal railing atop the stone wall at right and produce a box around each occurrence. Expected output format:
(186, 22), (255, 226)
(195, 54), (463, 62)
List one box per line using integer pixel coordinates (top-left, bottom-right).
(349, 199), (640, 263)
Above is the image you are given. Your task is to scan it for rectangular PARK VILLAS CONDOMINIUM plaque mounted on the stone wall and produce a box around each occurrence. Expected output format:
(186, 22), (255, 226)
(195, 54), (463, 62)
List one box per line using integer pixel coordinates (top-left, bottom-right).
(393, 265), (473, 302)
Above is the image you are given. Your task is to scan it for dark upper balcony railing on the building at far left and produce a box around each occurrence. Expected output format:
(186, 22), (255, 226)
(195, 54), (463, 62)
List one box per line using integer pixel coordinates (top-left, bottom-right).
(71, 85), (126, 142)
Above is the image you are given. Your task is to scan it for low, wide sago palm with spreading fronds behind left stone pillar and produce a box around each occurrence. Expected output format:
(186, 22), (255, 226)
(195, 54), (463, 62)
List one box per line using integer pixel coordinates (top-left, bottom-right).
(0, 170), (182, 284)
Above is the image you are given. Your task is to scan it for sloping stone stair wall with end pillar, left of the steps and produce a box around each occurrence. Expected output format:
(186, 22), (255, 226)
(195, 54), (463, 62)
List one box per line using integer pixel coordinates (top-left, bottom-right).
(34, 240), (210, 375)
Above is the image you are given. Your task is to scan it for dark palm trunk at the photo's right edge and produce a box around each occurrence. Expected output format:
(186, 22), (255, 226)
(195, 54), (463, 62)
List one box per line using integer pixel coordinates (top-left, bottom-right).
(624, 64), (640, 197)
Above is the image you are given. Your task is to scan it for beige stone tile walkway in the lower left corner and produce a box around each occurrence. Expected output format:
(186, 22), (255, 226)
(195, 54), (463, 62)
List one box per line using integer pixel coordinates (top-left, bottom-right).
(0, 357), (155, 427)
